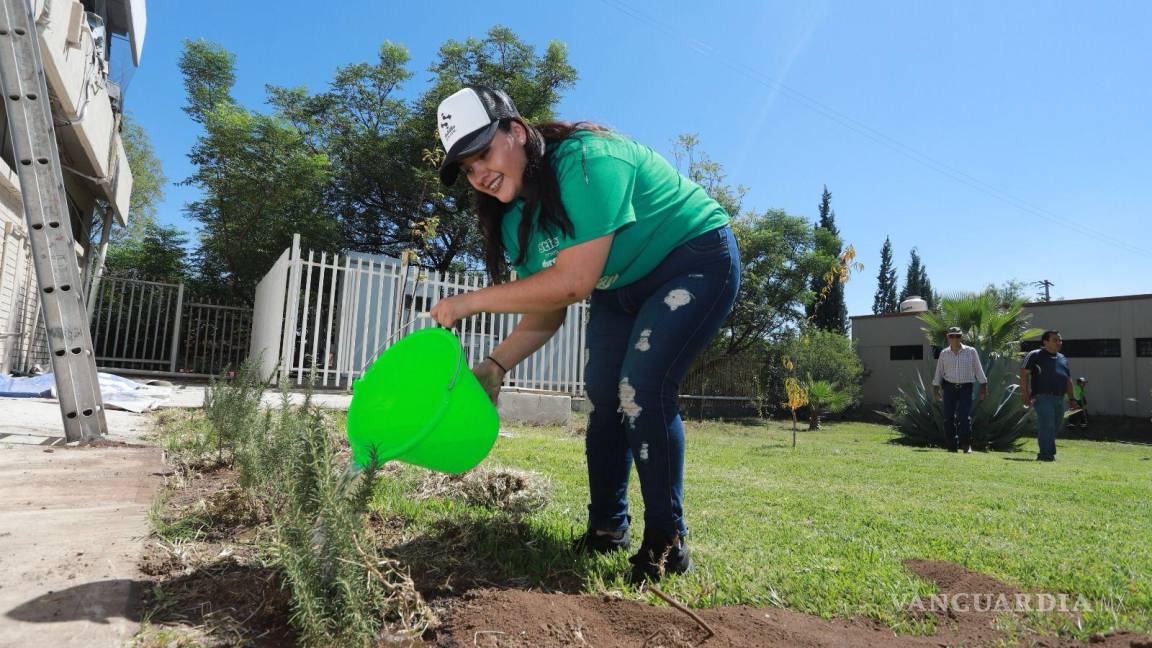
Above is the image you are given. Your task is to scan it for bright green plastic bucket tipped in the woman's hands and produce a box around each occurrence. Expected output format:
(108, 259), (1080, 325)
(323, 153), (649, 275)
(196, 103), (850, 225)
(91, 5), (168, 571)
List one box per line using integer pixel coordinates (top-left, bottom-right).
(348, 329), (500, 473)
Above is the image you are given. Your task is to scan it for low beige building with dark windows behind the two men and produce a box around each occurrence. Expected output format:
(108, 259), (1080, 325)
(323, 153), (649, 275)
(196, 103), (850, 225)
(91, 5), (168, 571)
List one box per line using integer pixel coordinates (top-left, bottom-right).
(851, 294), (1152, 417)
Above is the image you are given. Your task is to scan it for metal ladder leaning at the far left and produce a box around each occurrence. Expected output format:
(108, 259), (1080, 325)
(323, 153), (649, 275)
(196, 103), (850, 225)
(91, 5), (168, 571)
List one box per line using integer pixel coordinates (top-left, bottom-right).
(0, 0), (108, 442)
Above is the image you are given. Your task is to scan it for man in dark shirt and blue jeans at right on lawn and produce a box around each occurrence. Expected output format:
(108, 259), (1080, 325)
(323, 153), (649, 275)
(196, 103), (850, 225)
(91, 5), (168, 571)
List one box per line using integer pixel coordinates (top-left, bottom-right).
(1020, 331), (1074, 461)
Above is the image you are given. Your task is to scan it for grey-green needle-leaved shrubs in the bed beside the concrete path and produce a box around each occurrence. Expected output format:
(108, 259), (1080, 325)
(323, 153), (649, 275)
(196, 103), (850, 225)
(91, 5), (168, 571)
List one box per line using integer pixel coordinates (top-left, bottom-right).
(154, 364), (435, 647)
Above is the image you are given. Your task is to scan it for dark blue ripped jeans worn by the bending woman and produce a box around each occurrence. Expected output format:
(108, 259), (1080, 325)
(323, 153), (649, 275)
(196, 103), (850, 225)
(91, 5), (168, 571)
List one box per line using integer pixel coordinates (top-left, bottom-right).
(584, 227), (740, 537)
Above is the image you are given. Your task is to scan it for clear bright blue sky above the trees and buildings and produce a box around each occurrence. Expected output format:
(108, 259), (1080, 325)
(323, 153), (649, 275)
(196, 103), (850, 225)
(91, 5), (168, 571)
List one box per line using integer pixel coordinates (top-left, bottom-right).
(127, 0), (1152, 315)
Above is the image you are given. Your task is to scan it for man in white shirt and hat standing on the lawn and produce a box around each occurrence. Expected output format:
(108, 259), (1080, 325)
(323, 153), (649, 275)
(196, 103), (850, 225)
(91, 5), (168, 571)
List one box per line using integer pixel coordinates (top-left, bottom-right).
(932, 326), (988, 453)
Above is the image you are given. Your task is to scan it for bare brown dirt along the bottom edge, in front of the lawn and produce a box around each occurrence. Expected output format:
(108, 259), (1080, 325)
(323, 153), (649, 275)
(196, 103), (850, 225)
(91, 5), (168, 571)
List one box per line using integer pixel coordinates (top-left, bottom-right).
(432, 560), (1152, 648)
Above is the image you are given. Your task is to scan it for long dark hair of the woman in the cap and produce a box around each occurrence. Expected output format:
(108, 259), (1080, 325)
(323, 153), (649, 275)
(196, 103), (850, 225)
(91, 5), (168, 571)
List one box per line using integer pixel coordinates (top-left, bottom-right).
(476, 119), (608, 284)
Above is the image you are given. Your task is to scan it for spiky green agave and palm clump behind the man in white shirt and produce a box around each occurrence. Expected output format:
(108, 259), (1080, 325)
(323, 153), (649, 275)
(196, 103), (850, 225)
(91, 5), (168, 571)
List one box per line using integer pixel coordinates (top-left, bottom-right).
(881, 292), (1041, 451)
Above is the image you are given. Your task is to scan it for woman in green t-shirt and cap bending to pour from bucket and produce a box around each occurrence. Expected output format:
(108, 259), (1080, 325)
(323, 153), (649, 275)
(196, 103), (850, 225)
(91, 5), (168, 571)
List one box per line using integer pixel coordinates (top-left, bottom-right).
(432, 86), (740, 581)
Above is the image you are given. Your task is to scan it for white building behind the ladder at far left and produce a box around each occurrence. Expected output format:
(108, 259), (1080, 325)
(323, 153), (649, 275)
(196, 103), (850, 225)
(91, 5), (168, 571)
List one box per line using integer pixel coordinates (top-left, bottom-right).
(0, 0), (146, 372)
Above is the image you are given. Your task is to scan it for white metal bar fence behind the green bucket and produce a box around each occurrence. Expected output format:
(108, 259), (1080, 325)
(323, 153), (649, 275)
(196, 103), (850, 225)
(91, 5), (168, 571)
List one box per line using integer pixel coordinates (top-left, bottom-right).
(250, 236), (588, 394)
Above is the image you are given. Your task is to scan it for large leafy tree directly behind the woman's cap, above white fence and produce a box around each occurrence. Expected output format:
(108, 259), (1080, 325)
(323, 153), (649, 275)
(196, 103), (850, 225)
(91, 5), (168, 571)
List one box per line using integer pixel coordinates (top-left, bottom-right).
(268, 27), (576, 271)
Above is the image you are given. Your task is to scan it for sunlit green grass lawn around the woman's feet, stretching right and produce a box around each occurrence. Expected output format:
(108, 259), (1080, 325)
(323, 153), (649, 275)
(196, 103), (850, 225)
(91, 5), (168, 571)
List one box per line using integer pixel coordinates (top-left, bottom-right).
(376, 412), (1152, 636)
